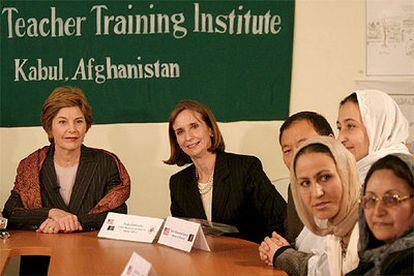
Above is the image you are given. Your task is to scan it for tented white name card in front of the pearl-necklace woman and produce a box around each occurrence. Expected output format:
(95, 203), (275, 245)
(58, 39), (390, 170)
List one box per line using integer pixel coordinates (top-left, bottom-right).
(158, 217), (210, 252)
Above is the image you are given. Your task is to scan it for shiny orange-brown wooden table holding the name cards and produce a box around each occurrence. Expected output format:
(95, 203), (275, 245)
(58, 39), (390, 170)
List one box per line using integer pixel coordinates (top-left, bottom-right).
(0, 231), (285, 276)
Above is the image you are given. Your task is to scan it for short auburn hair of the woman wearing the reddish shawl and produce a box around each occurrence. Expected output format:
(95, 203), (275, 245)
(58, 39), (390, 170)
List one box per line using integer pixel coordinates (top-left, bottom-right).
(40, 86), (92, 143)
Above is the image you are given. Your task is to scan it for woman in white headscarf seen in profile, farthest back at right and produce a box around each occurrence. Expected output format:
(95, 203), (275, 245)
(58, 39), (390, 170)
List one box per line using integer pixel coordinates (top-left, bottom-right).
(337, 90), (409, 182)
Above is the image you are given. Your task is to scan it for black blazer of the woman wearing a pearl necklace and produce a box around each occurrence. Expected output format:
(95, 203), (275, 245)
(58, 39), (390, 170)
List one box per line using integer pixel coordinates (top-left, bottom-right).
(170, 152), (286, 242)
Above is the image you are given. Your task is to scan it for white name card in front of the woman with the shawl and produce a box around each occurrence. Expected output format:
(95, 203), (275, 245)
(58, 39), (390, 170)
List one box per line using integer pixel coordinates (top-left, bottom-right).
(98, 212), (164, 243)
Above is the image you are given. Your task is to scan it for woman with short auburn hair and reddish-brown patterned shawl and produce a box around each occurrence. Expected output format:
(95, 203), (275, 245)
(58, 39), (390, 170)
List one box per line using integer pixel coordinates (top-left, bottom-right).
(3, 87), (130, 234)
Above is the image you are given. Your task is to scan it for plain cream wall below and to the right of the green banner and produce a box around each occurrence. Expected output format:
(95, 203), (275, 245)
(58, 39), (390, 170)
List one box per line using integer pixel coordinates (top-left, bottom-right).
(0, 0), (365, 217)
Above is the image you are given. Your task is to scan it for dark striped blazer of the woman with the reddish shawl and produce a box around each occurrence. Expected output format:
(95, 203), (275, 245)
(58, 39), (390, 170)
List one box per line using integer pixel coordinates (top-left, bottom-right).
(3, 145), (127, 231)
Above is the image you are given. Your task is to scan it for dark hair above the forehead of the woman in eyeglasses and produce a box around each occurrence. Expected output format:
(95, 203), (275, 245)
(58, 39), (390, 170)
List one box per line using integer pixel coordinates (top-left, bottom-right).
(364, 154), (414, 194)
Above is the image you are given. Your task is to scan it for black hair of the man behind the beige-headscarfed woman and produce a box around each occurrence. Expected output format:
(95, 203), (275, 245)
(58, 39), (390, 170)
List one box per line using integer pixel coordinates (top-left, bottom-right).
(279, 111), (334, 143)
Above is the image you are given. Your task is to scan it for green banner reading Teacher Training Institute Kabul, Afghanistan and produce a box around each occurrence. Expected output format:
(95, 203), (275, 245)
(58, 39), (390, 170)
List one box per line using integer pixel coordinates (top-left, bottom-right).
(0, 1), (294, 127)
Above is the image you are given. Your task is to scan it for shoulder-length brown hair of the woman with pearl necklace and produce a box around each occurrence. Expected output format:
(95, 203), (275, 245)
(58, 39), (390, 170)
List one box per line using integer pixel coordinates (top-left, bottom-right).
(164, 100), (225, 166)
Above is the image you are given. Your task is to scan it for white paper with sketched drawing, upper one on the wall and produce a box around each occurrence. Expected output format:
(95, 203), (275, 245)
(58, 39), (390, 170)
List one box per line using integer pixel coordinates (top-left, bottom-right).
(366, 0), (414, 75)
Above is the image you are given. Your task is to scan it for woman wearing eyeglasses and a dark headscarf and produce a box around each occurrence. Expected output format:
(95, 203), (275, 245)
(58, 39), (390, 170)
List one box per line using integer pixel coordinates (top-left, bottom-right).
(350, 154), (414, 275)
